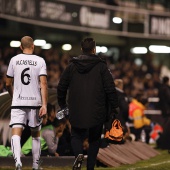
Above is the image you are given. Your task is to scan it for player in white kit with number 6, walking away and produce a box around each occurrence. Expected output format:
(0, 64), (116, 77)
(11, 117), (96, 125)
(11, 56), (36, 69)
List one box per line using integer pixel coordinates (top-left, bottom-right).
(6, 36), (48, 170)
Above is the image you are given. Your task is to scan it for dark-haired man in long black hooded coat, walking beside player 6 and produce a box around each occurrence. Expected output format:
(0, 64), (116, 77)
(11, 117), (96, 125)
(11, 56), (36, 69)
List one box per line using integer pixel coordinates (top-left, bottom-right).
(57, 38), (118, 170)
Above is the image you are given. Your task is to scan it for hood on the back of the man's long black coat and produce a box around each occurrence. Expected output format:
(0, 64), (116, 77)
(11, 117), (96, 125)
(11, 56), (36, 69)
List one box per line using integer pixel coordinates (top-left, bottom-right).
(70, 55), (106, 74)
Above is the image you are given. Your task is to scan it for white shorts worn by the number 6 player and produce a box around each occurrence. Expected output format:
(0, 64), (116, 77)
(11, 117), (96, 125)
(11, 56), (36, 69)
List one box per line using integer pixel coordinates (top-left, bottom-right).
(9, 109), (42, 128)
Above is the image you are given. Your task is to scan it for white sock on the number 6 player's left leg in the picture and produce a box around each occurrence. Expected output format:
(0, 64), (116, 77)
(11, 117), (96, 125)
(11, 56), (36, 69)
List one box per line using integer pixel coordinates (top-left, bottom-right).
(11, 135), (22, 166)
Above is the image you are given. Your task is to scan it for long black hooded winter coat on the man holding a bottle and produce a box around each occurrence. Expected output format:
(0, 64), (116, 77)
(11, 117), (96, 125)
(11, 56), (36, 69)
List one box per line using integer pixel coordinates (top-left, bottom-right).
(57, 55), (118, 128)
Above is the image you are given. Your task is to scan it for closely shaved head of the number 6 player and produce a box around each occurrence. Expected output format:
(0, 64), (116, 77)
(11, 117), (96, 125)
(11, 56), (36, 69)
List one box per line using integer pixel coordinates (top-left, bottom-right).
(21, 36), (34, 50)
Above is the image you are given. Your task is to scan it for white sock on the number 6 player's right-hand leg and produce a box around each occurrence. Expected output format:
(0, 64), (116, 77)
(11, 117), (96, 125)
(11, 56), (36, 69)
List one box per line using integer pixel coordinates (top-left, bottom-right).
(32, 137), (41, 169)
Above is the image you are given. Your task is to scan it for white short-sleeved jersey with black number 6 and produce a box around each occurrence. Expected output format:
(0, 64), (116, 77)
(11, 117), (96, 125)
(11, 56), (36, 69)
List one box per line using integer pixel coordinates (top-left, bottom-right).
(7, 54), (47, 108)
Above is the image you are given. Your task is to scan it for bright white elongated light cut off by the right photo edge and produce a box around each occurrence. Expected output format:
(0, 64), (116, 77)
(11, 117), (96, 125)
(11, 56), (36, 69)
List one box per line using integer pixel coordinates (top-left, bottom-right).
(149, 45), (170, 53)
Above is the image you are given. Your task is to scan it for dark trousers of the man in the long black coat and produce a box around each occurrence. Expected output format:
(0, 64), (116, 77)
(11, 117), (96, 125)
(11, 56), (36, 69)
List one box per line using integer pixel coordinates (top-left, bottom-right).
(71, 124), (103, 170)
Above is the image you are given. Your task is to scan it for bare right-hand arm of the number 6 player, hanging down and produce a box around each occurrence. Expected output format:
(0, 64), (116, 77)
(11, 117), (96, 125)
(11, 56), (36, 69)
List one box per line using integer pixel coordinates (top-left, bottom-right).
(39, 75), (48, 117)
